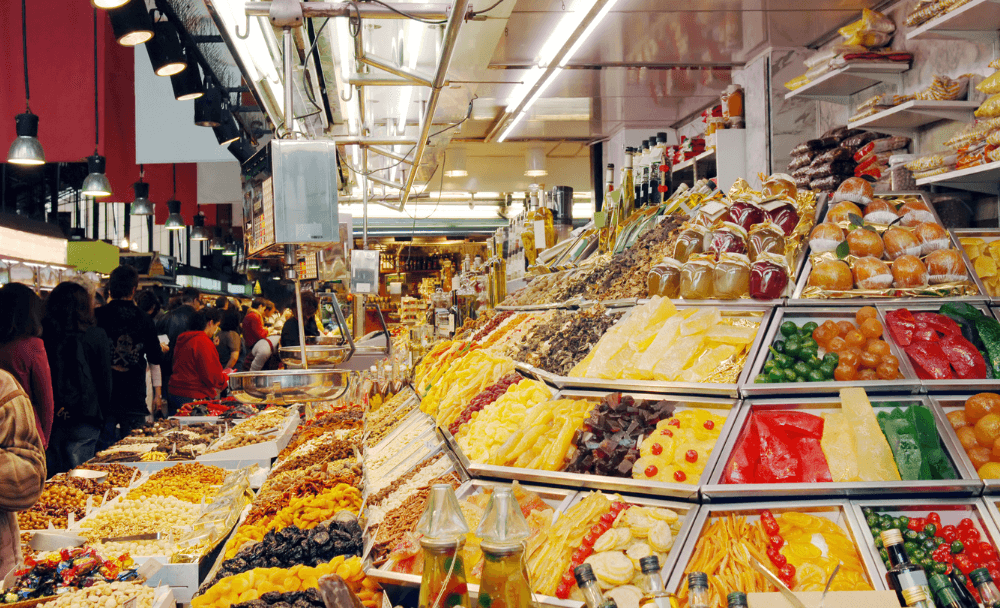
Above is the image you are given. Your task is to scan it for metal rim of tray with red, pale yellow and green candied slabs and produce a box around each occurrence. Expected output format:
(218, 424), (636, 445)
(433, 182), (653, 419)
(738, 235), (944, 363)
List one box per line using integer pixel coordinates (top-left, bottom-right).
(701, 395), (983, 502)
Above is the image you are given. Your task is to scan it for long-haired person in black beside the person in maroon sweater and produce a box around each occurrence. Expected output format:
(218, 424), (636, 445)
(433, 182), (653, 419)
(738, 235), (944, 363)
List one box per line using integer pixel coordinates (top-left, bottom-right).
(42, 282), (111, 475)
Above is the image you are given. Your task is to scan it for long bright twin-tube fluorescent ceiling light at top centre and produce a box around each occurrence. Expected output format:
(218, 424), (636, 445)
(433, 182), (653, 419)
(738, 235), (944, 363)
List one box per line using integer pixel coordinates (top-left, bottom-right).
(497, 0), (619, 143)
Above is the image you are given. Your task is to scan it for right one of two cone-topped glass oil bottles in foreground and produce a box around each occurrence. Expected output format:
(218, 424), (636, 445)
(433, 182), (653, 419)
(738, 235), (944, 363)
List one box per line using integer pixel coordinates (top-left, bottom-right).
(476, 487), (532, 608)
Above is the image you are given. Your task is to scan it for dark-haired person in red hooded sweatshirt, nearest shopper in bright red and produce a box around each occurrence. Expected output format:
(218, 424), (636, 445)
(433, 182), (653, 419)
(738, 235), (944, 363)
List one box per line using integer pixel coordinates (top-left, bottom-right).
(167, 308), (226, 415)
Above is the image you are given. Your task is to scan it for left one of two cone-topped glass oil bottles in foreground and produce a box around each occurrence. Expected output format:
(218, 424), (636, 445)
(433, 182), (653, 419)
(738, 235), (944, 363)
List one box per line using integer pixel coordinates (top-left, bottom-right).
(416, 484), (469, 608)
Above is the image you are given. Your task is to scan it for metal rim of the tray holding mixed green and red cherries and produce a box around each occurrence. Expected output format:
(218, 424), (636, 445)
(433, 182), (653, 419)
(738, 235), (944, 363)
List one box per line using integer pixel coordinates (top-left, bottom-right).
(851, 498), (1000, 581)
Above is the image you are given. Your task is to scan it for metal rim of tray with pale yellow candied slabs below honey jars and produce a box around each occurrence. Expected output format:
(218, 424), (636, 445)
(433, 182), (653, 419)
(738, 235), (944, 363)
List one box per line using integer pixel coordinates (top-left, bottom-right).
(554, 301), (774, 399)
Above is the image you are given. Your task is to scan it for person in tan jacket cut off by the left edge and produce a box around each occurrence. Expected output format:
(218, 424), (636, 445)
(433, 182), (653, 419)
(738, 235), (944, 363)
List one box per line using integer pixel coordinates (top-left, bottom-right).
(0, 371), (46, 572)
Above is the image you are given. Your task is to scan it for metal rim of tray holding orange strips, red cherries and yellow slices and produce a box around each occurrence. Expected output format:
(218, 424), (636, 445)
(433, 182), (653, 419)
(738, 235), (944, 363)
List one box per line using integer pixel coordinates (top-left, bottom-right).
(665, 500), (885, 594)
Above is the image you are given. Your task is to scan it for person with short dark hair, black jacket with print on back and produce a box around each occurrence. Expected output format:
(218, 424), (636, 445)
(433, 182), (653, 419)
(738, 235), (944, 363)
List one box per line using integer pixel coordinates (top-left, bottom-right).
(95, 265), (162, 448)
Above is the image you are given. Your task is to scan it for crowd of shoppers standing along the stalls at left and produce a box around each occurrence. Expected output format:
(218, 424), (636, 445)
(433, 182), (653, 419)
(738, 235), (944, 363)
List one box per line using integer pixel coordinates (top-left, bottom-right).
(0, 265), (320, 478)
